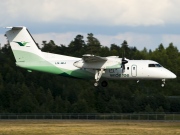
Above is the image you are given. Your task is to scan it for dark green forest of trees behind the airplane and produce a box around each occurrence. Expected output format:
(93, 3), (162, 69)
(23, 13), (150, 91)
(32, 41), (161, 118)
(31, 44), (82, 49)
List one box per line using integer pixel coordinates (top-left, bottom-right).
(0, 33), (180, 113)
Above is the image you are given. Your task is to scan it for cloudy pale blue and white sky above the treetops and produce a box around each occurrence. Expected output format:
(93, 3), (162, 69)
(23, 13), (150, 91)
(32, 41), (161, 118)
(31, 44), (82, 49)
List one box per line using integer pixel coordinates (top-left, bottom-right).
(0, 0), (180, 50)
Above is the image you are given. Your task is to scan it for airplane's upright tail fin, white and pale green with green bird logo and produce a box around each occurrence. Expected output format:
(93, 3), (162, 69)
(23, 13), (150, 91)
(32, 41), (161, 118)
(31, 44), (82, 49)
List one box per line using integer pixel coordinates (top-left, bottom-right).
(6, 27), (42, 62)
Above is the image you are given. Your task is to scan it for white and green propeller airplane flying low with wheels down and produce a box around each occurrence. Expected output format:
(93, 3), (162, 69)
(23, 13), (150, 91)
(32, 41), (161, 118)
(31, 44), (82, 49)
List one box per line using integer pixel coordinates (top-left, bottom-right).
(5, 26), (176, 87)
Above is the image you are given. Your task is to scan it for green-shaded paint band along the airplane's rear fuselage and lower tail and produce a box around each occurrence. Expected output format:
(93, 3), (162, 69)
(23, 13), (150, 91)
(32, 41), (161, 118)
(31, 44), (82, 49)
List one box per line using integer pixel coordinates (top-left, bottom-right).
(14, 50), (94, 78)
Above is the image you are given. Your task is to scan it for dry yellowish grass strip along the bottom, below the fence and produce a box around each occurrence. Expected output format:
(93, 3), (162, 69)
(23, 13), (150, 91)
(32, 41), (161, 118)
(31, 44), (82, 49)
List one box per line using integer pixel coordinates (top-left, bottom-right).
(0, 120), (180, 135)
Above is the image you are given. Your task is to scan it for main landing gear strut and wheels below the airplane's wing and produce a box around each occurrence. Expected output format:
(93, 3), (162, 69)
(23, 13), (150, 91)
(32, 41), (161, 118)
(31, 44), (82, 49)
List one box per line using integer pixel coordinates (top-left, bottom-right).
(94, 69), (108, 87)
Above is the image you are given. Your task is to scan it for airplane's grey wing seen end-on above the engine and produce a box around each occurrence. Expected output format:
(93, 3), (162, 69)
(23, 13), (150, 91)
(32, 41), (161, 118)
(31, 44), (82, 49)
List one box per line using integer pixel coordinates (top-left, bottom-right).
(82, 54), (107, 63)
